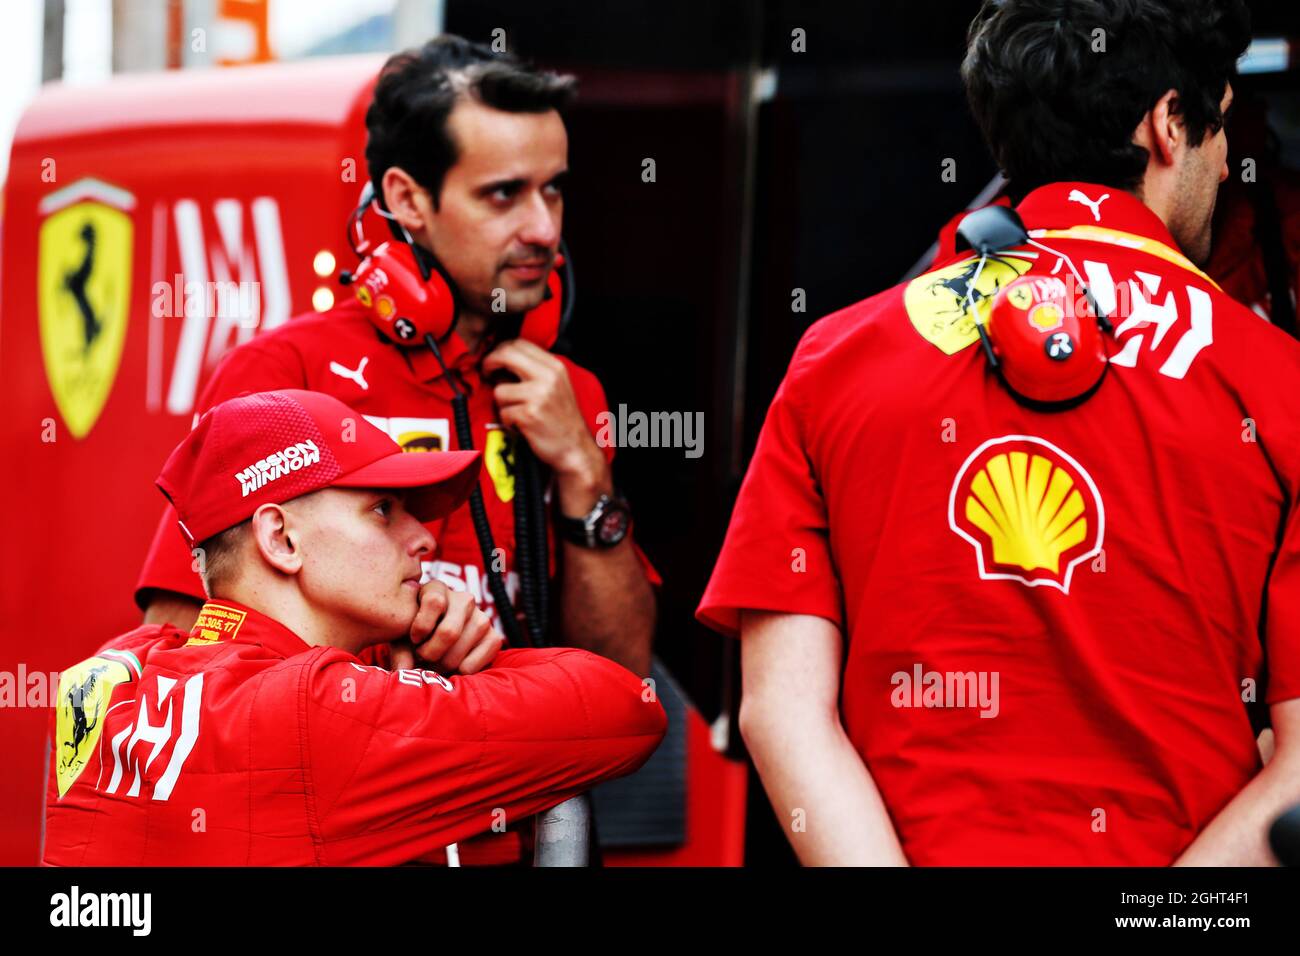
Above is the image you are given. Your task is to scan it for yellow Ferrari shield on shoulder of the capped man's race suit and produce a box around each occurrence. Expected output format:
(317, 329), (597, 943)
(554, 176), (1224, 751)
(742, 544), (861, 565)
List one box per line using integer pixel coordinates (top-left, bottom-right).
(55, 650), (140, 797)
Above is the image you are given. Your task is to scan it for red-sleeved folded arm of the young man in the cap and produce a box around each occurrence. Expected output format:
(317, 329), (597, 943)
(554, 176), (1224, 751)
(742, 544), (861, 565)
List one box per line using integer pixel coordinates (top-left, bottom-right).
(307, 648), (667, 845)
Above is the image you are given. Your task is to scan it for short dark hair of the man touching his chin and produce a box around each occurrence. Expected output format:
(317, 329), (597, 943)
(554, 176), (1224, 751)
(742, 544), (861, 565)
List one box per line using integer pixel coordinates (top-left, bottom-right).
(365, 35), (577, 208)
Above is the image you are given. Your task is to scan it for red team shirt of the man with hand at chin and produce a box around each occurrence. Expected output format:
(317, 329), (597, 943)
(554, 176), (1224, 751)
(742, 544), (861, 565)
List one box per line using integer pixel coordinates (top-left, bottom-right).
(135, 298), (659, 865)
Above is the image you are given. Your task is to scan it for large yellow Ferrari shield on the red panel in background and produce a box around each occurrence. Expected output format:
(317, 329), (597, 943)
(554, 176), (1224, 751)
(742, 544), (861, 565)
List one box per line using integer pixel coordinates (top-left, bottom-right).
(36, 179), (135, 438)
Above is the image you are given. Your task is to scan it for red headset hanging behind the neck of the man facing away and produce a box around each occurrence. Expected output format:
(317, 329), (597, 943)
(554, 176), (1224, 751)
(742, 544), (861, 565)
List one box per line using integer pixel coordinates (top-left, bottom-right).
(957, 206), (1112, 411)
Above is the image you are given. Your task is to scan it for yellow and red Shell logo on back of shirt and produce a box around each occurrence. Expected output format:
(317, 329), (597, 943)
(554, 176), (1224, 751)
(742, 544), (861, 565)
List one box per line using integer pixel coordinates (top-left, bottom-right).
(948, 434), (1106, 594)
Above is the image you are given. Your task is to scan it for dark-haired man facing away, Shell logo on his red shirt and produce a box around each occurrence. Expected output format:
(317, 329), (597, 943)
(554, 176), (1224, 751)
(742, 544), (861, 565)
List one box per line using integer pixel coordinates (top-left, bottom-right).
(698, 0), (1300, 866)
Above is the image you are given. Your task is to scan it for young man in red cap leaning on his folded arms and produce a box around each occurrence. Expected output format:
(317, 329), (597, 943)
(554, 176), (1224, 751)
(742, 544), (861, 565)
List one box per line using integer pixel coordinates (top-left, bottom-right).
(44, 390), (666, 865)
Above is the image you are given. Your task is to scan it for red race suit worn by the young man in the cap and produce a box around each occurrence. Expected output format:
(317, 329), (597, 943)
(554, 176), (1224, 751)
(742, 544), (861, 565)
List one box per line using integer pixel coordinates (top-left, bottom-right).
(44, 601), (666, 866)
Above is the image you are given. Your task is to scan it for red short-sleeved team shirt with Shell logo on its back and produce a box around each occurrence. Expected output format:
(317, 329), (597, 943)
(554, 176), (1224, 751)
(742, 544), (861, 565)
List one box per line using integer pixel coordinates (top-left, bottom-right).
(698, 183), (1300, 865)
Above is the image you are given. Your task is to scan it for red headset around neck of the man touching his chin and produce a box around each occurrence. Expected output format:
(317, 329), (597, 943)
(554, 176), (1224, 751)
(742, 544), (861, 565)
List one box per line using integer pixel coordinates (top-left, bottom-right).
(339, 182), (573, 360)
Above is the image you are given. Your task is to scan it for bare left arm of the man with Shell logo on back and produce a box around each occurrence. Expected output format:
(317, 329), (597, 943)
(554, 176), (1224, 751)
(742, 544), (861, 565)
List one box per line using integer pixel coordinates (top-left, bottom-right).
(740, 611), (907, 866)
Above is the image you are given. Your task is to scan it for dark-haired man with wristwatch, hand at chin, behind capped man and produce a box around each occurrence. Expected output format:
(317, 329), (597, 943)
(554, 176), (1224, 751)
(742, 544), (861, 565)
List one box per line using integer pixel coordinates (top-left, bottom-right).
(137, 36), (658, 864)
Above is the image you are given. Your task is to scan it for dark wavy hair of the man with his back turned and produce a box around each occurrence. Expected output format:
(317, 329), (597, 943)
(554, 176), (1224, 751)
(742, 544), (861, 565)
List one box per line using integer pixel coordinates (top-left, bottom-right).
(962, 0), (1251, 196)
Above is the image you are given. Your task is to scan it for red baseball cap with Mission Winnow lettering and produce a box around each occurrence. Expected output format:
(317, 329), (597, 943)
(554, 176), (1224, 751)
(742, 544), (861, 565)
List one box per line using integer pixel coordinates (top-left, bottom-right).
(157, 389), (480, 548)
